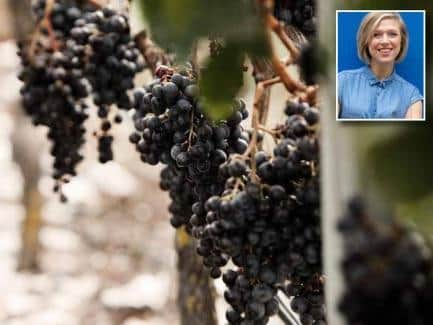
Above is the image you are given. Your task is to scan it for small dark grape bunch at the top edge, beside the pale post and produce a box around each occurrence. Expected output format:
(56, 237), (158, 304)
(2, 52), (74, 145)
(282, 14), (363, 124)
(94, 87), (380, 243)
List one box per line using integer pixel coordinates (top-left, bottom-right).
(274, 0), (317, 37)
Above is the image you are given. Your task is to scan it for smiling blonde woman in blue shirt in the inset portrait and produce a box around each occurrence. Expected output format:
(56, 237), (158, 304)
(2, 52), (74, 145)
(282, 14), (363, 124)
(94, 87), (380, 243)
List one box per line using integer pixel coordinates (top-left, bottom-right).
(338, 12), (423, 119)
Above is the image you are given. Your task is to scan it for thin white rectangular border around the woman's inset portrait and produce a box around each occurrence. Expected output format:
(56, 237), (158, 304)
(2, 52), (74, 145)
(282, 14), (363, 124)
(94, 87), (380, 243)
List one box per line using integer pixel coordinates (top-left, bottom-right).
(335, 9), (427, 122)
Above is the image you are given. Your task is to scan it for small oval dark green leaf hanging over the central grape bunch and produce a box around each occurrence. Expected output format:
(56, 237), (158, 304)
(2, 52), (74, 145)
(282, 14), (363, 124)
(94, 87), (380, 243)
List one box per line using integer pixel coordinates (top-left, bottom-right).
(199, 44), (244, 120)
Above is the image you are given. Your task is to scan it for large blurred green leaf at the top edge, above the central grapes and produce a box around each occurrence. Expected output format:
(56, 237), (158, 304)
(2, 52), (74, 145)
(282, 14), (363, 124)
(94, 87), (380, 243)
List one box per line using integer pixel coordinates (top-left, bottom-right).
(137, 0), (268, 61)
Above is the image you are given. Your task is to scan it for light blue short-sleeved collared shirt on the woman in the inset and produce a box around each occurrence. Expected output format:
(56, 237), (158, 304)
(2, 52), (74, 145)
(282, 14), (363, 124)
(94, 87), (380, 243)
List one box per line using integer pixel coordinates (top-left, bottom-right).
(338, 66), (423, 119)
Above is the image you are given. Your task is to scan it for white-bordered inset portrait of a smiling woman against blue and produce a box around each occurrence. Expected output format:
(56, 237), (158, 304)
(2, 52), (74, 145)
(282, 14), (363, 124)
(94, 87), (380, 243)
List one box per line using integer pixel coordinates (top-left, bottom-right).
(336, 10), (425, 121)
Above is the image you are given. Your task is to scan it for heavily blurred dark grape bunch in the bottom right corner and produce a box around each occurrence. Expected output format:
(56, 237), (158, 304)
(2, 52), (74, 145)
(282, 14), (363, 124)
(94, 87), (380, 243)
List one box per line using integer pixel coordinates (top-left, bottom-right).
(339, 198), (433, 325)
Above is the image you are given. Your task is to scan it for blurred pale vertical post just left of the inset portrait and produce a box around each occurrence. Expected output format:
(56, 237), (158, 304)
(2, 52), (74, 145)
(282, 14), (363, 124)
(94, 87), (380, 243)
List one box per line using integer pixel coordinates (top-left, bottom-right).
(318, 0), (359, 325)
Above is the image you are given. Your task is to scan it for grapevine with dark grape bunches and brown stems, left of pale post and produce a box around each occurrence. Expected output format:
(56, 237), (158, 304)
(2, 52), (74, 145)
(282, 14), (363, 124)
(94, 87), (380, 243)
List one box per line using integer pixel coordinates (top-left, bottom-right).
(20, 0), (326, 325)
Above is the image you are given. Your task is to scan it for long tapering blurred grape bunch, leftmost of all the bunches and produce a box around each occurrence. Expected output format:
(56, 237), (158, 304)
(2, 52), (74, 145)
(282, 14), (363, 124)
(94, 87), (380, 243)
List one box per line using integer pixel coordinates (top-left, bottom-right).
(19, 1), (95, 196)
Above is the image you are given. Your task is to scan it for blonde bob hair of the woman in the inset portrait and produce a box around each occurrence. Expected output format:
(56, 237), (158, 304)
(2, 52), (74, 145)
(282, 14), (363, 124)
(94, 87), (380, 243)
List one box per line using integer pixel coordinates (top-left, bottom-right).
(356, 12), (409, 64)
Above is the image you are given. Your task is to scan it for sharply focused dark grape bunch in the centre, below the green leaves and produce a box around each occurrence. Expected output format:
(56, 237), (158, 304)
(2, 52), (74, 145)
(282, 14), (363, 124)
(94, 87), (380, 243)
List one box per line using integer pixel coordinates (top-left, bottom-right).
(130, 69), (248, 229)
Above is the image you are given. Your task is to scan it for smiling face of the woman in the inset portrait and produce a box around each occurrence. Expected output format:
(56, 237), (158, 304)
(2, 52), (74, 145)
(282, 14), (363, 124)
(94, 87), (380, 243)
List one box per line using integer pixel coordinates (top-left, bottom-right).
(368, 18), (401, 64)
